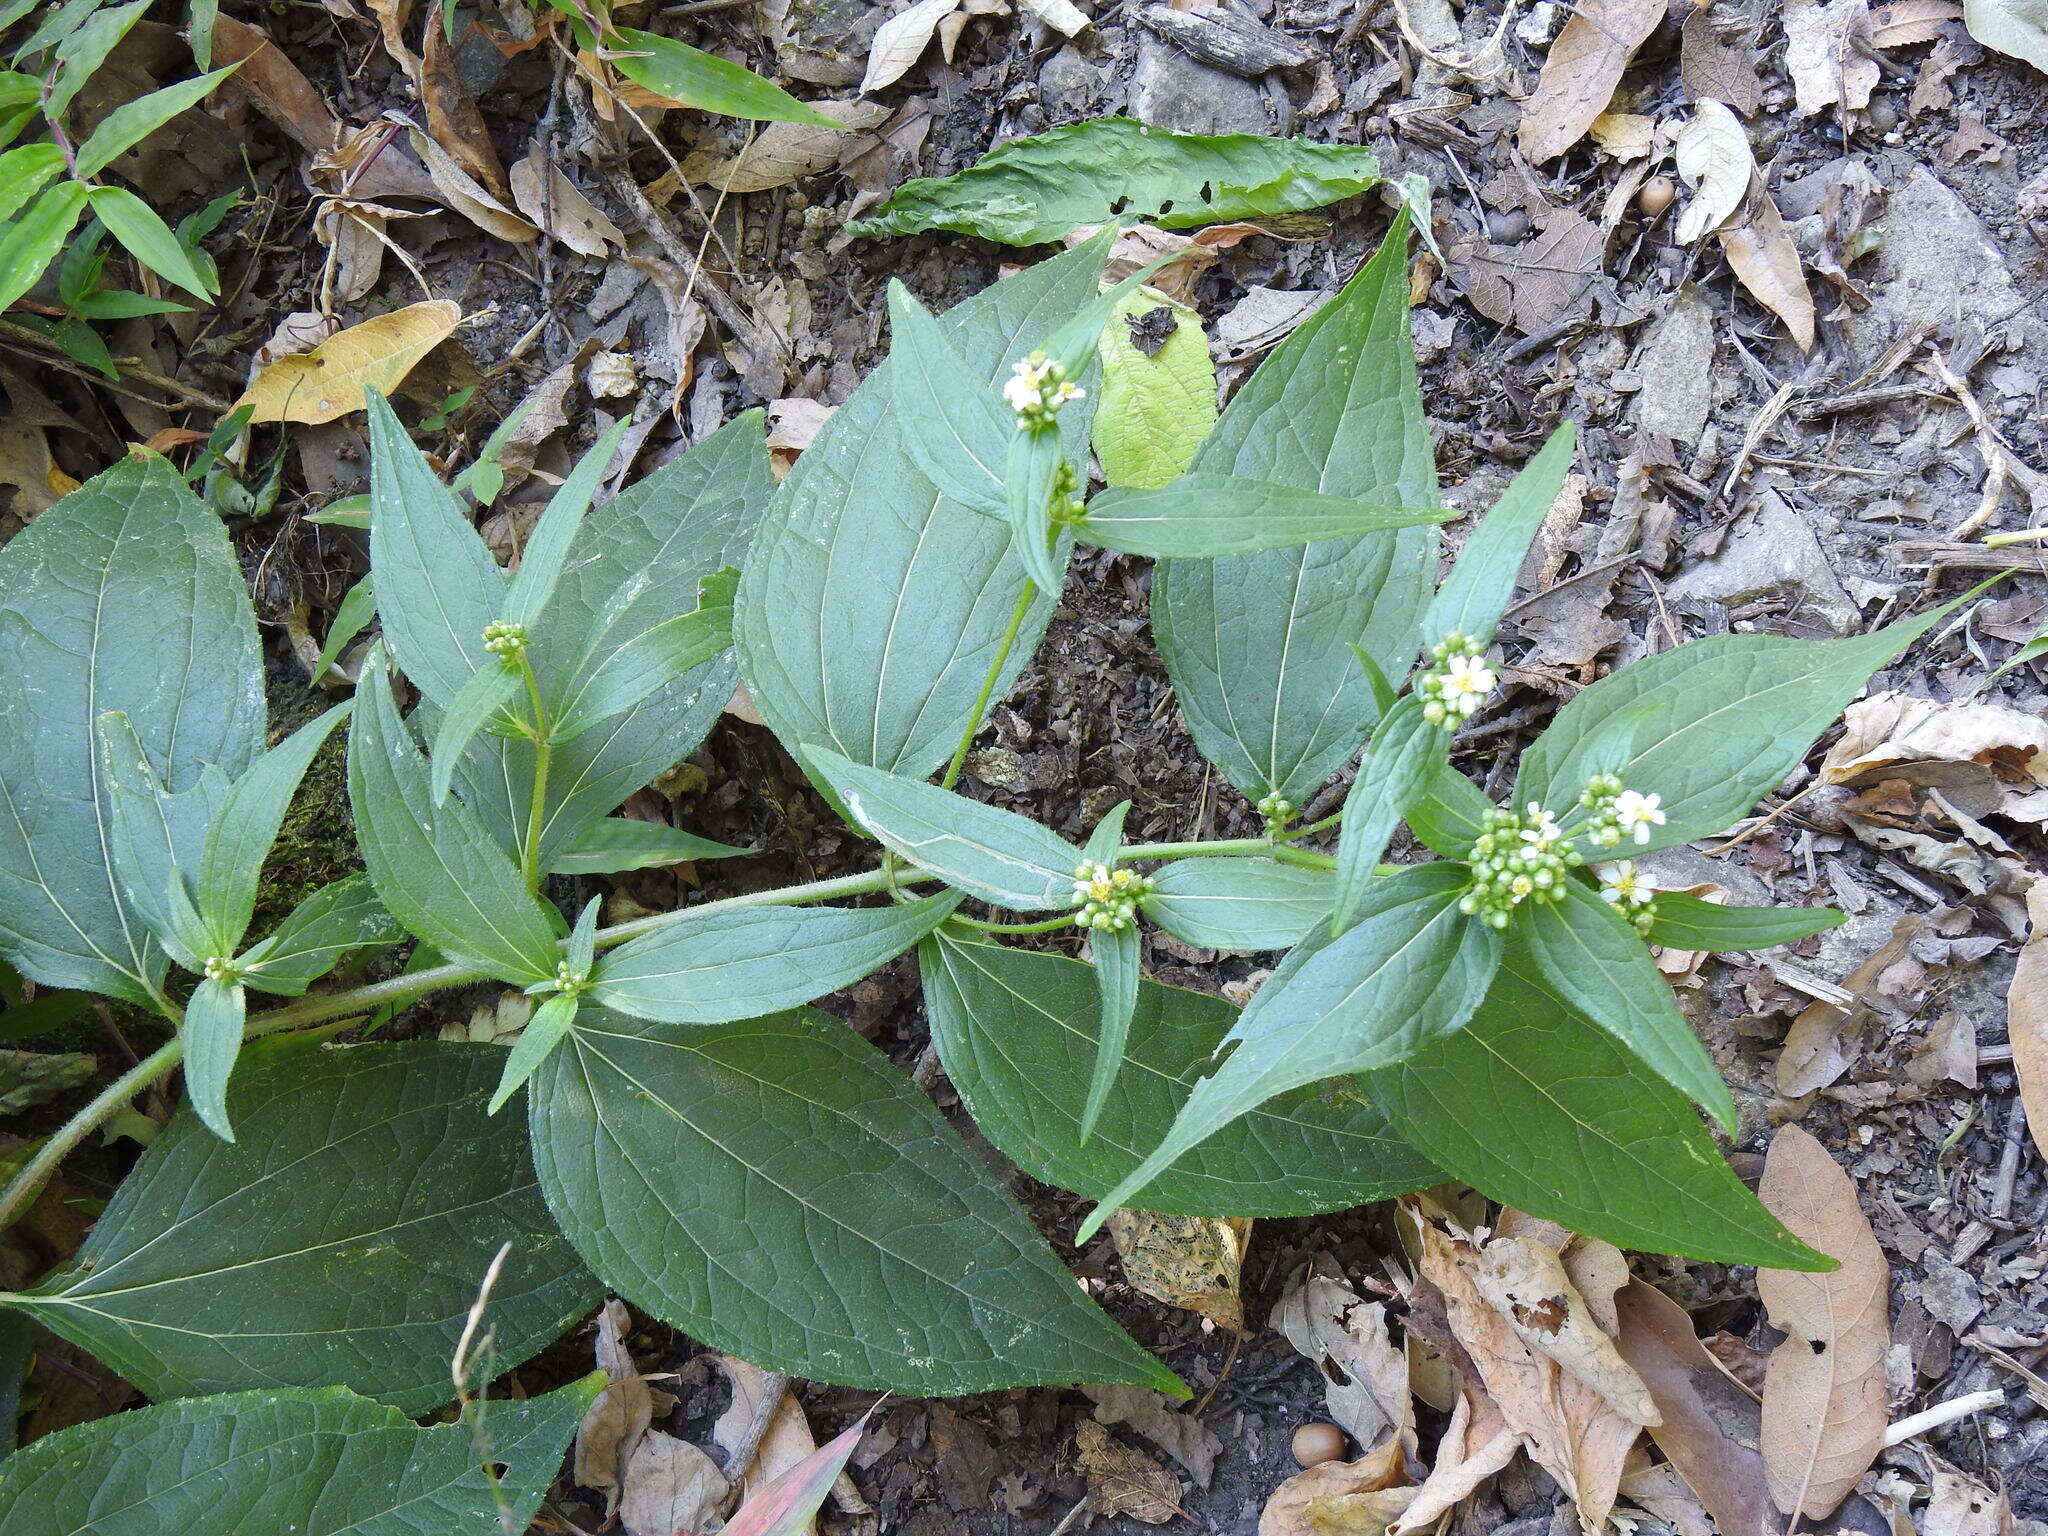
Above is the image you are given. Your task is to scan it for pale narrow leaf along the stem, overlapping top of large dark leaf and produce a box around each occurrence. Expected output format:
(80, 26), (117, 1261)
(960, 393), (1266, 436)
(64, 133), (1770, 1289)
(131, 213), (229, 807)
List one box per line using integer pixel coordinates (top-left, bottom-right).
(592, 891), (961, 1024)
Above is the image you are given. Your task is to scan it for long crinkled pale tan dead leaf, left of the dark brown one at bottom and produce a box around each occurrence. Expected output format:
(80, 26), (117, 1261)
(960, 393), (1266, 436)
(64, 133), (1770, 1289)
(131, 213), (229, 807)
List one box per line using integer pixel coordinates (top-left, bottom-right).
(1419, 1221), (1642, 1532)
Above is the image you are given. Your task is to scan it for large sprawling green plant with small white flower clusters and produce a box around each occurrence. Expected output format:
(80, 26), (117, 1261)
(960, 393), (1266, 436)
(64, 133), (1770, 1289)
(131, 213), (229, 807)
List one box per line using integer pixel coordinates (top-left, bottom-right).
(0, 215), (1933, 1507)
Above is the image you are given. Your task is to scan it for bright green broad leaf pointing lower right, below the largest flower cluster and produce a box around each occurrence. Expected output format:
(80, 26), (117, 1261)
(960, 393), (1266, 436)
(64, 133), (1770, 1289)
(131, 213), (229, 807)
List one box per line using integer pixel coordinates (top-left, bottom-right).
(1362, 946), (1819, 1270)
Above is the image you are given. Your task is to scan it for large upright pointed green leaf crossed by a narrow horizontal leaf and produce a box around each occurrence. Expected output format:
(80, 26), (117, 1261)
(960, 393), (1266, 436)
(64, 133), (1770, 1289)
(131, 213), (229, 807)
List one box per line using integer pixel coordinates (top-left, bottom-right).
(1153, 219), (1438, 805)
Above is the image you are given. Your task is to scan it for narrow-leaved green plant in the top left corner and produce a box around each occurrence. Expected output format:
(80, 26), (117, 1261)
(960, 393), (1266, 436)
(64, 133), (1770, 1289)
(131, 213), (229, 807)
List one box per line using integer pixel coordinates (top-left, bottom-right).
(0, 0), (233, 319)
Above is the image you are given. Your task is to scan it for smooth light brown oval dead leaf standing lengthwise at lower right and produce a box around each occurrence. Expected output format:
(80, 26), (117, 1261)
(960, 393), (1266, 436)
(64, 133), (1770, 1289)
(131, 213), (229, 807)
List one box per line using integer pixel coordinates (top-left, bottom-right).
(1757, 1124), (1890, 1520)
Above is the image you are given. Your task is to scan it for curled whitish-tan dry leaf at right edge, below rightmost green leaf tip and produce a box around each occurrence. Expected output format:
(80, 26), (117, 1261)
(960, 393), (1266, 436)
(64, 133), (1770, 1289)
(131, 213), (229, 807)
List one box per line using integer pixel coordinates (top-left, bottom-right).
(1821, 692), (2048, 821)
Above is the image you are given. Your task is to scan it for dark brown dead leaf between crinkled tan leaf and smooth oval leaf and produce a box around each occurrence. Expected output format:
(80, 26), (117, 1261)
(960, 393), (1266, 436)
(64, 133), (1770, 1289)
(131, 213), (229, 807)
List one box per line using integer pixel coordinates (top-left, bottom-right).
(1616, 1280), (1780, 1536)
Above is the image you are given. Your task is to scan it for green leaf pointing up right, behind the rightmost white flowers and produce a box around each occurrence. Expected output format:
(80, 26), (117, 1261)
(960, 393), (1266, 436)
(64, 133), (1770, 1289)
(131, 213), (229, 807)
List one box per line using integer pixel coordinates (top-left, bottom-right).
(1516, 604), (1954, 848)
